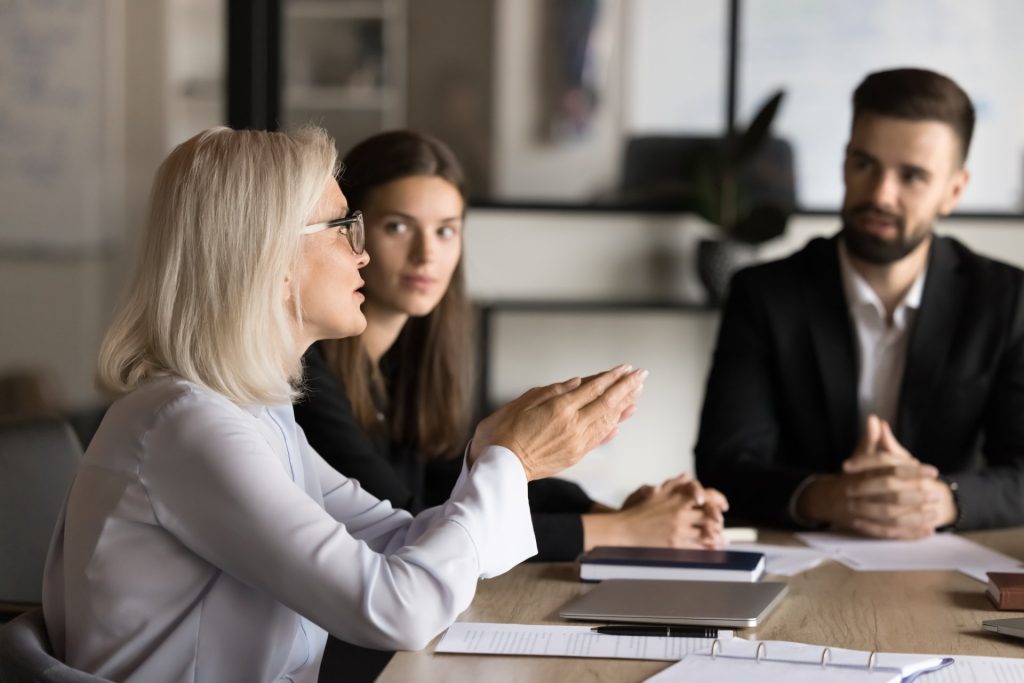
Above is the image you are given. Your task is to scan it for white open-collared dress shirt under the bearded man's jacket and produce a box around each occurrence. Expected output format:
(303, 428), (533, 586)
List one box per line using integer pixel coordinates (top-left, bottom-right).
(839, 241), (928, 428)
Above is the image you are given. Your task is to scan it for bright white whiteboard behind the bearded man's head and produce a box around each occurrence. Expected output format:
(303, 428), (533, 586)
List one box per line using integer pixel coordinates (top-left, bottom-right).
(737, 0), (1024, 213)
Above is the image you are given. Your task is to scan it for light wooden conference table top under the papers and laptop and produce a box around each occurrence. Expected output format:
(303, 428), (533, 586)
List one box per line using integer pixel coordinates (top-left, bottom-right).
(378, 527), (1024, 683)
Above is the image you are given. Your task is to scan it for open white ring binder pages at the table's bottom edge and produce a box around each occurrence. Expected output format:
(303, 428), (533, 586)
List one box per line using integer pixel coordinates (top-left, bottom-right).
(647, 638), (953, 683)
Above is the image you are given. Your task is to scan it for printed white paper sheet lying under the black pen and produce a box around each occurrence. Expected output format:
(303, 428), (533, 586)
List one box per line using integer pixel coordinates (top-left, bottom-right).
(434, 622), (732, 661)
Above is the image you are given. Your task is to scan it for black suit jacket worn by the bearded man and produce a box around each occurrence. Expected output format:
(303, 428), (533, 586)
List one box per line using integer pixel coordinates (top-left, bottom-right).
(695, 237), (1024, 529)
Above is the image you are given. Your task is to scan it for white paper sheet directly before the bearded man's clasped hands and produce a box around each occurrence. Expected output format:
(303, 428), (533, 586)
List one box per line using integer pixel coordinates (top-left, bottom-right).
(797, 532), (1024, 582)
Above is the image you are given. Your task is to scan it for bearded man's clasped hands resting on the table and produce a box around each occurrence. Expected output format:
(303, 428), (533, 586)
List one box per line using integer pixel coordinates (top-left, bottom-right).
(797, 415), (956, 539)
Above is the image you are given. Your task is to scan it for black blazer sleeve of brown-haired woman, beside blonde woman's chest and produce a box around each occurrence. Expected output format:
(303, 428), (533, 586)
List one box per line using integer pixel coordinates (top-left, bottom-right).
(295, 346), (416, 510)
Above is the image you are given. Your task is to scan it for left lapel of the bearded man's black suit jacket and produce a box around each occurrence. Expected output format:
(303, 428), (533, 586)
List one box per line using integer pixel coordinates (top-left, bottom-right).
(805, 238), (860, 466)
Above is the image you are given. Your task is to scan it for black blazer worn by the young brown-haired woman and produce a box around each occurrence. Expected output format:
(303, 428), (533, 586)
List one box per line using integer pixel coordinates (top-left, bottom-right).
(295, 344), (594, 561)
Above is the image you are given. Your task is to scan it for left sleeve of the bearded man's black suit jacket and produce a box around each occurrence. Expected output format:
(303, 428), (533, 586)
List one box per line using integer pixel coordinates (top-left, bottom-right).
(694, 270), (821, 525)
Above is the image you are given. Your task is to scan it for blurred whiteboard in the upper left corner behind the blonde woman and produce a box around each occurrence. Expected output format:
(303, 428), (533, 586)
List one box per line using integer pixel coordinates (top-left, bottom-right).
(0, 0), (115, 251)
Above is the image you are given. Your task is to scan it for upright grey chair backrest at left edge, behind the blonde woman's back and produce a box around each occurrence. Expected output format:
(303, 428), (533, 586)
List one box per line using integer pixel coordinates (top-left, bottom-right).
(0, 419), (82, 604)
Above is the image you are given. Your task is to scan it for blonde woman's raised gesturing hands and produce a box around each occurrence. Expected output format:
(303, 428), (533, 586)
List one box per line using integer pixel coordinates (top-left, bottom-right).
(469, 366), (647, 480)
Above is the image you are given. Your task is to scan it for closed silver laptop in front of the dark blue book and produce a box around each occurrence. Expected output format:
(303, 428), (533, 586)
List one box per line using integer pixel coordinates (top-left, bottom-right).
(559, 579), (786, 629)
